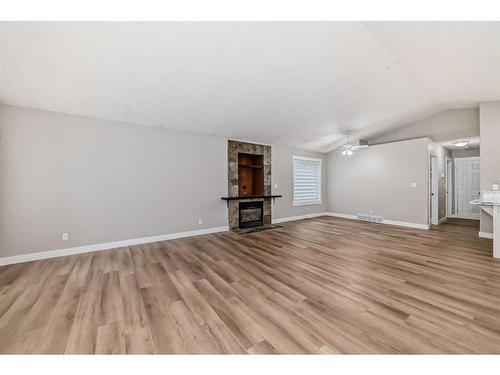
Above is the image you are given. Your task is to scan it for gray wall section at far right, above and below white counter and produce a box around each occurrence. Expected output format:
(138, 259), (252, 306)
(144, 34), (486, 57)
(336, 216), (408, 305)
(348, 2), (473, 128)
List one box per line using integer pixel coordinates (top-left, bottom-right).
(479, 101), (500, 233)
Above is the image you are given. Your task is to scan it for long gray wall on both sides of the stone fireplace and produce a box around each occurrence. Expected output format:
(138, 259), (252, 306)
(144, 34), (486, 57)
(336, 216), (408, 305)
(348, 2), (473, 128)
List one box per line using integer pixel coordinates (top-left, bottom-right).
(0, 105), (326, 257)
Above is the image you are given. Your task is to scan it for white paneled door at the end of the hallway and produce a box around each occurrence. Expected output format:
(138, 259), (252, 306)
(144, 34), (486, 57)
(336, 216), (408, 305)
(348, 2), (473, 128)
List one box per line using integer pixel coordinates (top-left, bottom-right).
(455, 157), (480, 220)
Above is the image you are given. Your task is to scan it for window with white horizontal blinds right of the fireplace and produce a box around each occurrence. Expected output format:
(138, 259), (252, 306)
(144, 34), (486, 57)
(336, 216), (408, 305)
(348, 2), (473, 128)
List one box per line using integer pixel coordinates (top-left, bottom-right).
(293, 156), (321, 206)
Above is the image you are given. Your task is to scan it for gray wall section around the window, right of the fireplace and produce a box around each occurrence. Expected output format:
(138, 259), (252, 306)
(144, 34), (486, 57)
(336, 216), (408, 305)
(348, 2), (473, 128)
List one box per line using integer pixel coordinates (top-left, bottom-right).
(272, 146), (328, 219)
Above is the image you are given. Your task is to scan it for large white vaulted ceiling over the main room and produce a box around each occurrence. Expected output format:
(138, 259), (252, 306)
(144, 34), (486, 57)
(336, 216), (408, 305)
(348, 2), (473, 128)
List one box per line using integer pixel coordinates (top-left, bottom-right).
(0, 22), (500, 151)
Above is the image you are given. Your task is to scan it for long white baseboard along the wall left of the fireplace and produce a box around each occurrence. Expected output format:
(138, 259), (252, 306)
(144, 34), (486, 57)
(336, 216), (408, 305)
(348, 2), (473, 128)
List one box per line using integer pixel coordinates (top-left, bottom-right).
(0, 226), (229, 266)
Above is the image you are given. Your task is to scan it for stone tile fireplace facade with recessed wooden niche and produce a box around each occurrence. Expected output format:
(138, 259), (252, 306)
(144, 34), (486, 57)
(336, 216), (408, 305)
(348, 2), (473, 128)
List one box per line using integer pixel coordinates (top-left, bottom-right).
(227, 140), (271, 230)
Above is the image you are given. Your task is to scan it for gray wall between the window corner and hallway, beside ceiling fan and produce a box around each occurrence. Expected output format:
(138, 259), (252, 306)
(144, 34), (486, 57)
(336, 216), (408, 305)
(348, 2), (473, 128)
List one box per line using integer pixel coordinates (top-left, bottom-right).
(327, 138), (430, 225)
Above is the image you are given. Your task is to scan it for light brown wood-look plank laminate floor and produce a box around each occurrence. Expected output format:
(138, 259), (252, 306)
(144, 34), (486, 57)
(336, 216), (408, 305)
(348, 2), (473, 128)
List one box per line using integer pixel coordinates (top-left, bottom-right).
(0, 217), (500, 354)
